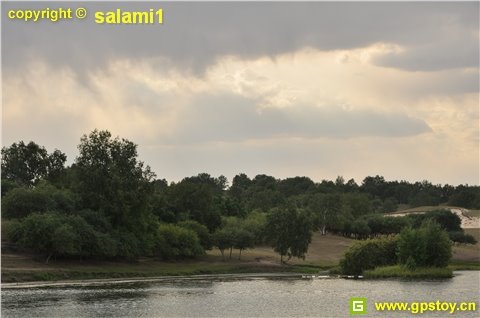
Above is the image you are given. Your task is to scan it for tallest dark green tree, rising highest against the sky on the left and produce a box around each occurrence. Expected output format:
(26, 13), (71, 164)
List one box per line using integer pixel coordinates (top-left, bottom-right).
(76, 130), (154, 229)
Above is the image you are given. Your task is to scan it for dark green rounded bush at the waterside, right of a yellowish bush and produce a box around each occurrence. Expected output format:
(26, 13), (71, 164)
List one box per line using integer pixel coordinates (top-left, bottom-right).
(397, 220), (452, 267)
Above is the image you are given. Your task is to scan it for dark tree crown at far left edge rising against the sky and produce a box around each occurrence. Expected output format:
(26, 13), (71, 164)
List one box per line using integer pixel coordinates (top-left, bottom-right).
(1, 141), (67, 186)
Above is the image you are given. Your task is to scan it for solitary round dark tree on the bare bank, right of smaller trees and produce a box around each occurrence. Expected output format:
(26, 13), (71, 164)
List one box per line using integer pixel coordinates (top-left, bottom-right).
(266, 207), (312, 264)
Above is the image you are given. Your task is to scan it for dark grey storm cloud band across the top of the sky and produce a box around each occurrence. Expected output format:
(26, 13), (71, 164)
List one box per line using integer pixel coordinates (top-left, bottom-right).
(2, 2), (479, 73)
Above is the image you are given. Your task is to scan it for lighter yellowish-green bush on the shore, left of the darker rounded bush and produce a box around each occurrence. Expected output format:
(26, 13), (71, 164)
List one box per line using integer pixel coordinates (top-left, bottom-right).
(340, 238), (397, 275)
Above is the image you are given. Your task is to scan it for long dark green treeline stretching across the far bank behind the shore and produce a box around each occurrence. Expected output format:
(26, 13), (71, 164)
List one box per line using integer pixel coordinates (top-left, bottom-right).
(1, 130), (480, 259)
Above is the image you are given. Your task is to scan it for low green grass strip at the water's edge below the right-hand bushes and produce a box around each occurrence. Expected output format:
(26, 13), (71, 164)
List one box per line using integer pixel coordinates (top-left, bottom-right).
(363, 265), (453, 279)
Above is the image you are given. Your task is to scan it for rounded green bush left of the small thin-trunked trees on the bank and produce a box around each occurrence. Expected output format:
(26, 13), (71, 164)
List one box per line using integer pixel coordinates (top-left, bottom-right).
(156, 224), (205, 259)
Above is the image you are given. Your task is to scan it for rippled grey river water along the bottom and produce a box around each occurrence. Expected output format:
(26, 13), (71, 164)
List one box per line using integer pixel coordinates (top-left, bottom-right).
(2, 271), (480, 318)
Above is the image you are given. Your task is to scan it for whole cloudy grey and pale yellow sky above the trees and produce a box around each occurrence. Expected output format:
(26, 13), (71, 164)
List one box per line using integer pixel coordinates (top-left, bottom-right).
(1, 2), (480, 185)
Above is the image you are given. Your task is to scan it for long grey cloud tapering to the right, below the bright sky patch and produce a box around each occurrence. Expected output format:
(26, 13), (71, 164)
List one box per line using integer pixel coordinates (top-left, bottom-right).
(171, 95), (431, 143)
